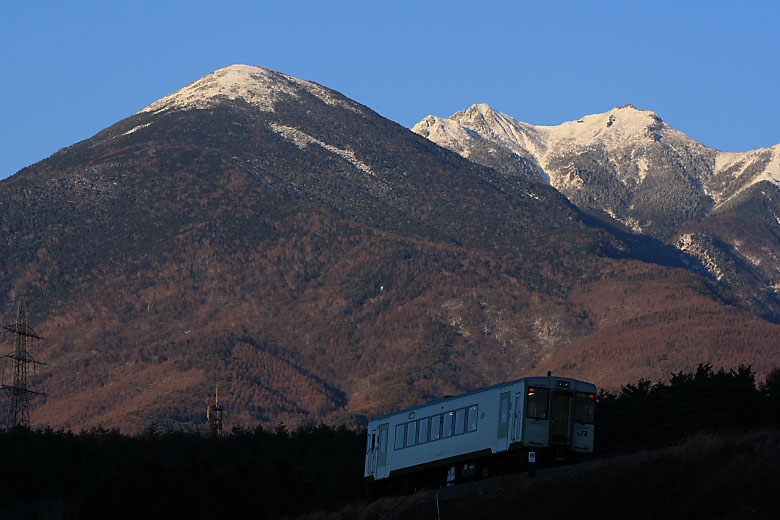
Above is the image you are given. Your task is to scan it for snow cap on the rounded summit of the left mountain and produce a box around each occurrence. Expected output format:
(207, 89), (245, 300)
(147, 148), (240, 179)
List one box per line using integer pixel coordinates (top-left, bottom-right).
(141, 65), (360, 113)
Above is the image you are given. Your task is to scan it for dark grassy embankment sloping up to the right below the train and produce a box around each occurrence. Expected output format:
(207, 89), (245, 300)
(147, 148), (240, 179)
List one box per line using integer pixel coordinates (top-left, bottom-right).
(301, 430), (780, 520)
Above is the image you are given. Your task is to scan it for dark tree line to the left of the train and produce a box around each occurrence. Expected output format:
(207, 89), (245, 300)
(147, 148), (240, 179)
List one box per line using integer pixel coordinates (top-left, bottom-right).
(0, 425), (365, 519)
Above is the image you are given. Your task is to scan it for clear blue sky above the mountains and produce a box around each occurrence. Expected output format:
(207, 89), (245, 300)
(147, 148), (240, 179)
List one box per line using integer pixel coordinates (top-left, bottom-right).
(0, 0), (780, 178)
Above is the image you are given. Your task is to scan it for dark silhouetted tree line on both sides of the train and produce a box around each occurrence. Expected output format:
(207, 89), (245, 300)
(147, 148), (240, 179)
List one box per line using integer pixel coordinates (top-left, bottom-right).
(0, 365), (780, 519)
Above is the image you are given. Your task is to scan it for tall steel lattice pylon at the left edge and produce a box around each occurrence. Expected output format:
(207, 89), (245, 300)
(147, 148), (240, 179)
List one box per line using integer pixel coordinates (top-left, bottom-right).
(2, 300), (46, 428)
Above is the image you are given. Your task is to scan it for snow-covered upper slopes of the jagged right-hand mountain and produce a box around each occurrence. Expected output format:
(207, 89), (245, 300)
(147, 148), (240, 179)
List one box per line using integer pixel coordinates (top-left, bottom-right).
(412, 103), (780, 230)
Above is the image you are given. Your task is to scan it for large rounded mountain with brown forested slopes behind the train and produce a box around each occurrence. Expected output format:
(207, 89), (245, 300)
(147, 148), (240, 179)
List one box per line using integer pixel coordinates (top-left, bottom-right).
(0, 65), (780, 431)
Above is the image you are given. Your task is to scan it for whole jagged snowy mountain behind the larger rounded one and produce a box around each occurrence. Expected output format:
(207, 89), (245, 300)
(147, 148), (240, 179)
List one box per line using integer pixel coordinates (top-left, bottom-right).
(412, 104), (780, 319)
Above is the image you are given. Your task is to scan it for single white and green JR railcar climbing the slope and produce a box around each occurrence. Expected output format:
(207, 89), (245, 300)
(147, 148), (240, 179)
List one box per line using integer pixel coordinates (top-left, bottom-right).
(364, 373), (596, 485)
